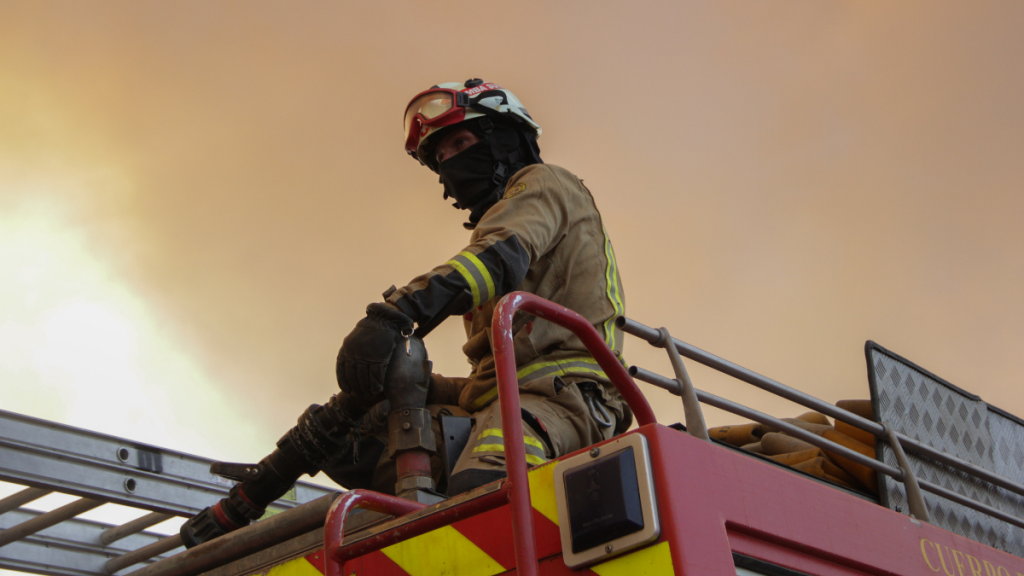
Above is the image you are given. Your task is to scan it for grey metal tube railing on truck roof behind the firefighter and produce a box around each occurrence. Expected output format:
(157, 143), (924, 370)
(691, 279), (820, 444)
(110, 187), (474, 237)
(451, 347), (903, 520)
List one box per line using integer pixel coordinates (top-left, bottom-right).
(615, 317), (1024, 528)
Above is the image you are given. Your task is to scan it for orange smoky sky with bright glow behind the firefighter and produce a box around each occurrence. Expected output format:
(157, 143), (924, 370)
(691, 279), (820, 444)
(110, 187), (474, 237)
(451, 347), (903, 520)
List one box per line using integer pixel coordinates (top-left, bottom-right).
(0, 0), (1024, 475)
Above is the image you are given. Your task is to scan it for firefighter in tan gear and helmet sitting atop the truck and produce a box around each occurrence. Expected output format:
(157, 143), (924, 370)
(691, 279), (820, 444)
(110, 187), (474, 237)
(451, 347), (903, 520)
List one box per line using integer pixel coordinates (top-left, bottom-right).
(328, 79), (632, 494)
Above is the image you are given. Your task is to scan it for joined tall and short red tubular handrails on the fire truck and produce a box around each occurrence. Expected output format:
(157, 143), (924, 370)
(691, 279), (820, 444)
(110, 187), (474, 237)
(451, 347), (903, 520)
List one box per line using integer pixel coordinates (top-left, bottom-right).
(324, 292), (657, 576)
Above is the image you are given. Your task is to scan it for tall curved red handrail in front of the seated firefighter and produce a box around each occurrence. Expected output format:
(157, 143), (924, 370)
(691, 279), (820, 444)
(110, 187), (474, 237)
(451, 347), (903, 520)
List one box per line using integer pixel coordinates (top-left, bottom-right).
(490, 292), (657, 576)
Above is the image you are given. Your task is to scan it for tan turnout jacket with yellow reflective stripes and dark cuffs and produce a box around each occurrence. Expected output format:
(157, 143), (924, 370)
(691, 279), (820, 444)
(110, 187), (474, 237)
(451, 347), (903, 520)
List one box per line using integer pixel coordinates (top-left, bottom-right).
(387, 164), (629, 425)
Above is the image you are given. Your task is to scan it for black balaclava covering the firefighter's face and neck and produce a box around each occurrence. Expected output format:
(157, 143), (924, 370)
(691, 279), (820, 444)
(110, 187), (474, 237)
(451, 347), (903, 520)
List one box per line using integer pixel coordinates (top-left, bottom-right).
(436, 117), (542, 230)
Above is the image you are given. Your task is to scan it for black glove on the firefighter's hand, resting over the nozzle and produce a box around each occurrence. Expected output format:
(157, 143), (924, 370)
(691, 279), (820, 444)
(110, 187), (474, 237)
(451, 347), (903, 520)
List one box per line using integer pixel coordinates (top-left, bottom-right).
(335, 302), (413, 400)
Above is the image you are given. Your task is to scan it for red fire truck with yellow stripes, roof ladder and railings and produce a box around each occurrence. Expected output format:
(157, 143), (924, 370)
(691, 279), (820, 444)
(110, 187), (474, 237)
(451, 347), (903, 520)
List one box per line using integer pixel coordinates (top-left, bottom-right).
(0, 292), (1024, 576)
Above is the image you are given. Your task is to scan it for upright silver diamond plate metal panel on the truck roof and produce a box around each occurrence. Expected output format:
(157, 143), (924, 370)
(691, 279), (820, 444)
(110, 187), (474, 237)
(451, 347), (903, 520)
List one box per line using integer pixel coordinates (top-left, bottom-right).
(864, 340), (1024, 558)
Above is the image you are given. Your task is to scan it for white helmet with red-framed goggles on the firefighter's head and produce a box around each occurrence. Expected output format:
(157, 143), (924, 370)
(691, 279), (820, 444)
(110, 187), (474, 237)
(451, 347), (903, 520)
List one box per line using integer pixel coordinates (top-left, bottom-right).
(406, 78), (541, 162)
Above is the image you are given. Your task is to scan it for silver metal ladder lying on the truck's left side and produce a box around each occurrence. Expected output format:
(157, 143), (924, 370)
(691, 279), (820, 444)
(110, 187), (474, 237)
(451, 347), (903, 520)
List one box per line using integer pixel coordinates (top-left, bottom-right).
(0, 410), (333, 576)
